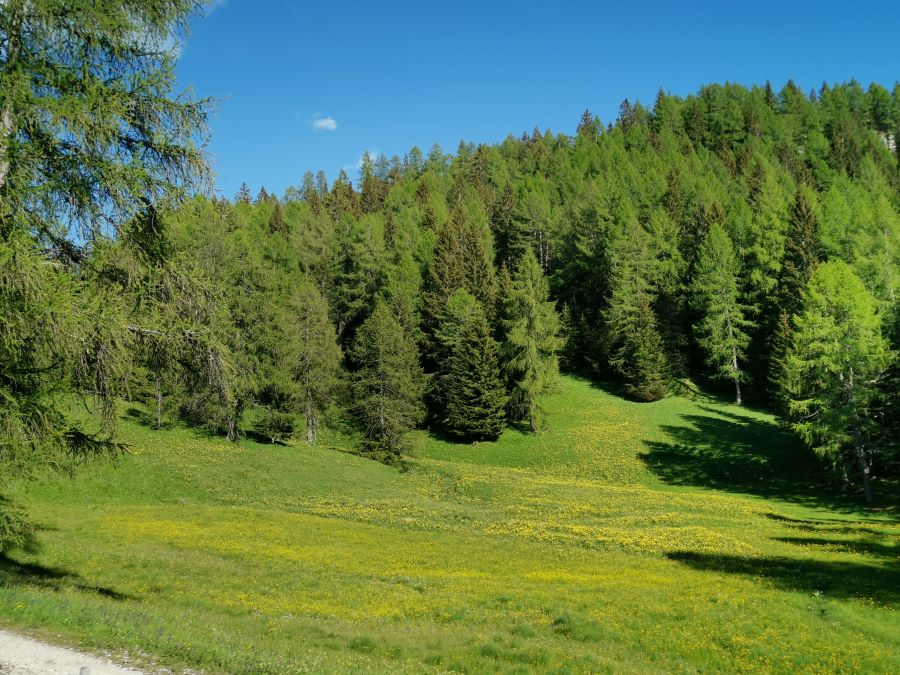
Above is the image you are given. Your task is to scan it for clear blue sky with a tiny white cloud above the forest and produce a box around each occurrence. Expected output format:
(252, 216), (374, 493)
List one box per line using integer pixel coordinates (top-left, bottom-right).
(177, 0), (900, 197)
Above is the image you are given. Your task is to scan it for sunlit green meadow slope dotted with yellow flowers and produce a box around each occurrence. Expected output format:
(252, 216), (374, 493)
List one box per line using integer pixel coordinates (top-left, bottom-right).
(0, 378), (900, 672)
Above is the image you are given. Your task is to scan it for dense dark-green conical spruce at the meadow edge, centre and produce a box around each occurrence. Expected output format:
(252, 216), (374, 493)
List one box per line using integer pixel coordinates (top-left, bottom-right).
(436, 290), (507, 440)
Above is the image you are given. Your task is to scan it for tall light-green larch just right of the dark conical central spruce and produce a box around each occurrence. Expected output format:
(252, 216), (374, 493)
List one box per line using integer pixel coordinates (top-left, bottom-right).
(501, 250), (562, 432)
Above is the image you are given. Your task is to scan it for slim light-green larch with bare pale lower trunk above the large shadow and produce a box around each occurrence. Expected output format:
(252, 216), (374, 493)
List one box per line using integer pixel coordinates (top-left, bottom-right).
(692, 227), (754, 405)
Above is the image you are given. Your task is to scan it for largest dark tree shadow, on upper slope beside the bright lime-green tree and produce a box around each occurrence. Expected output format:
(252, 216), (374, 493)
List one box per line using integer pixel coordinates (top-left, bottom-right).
(640, 406), (888, 512)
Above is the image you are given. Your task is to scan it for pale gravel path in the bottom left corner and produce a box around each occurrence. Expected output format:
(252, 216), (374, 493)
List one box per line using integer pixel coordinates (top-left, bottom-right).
(0, 630), (141, 675)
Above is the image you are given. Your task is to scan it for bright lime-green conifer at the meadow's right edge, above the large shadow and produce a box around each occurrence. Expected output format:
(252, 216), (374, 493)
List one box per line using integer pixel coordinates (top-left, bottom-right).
(782, 262), (891, 503)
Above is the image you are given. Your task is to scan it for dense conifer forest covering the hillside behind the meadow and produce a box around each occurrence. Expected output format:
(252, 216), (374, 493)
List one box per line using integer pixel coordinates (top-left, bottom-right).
(107, 82), (900, 502)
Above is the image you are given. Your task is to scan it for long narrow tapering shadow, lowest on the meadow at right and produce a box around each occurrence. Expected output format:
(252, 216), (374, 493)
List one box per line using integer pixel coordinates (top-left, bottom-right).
(666, 551), (900, 604)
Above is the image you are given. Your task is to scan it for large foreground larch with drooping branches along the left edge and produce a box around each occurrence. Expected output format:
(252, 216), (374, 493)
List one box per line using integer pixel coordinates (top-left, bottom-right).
(0, 0), (208, 548)
